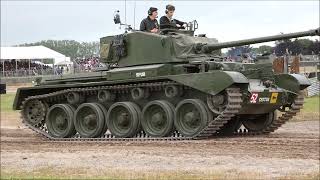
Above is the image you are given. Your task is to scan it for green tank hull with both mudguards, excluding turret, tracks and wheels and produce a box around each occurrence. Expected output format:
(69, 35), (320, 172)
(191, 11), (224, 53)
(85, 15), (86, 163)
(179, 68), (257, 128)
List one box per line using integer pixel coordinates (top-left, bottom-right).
(13, 65), (311, 114)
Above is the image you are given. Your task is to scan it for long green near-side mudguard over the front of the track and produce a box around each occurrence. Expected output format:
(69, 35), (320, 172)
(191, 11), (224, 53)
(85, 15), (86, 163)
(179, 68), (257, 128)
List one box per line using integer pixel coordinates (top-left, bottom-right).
(168, 71), (249, 95)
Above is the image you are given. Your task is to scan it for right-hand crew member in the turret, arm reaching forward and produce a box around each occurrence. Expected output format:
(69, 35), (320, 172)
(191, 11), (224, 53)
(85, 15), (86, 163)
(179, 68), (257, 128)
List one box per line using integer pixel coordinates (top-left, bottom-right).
(160, 4), (187, 29)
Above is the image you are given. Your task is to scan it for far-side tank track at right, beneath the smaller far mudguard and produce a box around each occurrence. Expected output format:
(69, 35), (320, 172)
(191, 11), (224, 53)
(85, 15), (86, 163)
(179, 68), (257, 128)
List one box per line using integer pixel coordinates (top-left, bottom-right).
(234, 92), (304, 136)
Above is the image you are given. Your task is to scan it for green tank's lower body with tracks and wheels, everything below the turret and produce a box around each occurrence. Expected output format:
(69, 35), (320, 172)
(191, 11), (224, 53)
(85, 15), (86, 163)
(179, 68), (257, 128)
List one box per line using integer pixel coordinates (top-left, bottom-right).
(13, 66), (309, 140)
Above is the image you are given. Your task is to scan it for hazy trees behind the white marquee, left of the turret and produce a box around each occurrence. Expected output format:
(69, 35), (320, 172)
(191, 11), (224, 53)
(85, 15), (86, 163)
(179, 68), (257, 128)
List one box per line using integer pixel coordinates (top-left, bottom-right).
(18, 40), (100, 59)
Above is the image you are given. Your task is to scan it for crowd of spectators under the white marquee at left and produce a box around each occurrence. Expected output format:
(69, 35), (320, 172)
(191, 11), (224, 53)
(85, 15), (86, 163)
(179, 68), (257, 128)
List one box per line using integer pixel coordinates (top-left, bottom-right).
(0, 59), (53, 77)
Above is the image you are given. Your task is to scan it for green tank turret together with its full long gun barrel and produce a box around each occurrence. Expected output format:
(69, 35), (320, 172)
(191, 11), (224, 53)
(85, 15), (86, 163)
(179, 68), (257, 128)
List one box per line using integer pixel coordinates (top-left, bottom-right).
(100, 28), (319, 67)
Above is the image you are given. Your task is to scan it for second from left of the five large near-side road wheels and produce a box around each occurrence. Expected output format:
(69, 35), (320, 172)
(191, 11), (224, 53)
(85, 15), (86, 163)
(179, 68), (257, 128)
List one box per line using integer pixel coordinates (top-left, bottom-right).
(74, 103), (105, 138)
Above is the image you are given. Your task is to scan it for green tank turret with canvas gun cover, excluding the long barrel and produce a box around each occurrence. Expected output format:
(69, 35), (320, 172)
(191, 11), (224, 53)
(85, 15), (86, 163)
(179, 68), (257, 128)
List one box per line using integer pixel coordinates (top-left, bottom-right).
(100, 31), (218, 67)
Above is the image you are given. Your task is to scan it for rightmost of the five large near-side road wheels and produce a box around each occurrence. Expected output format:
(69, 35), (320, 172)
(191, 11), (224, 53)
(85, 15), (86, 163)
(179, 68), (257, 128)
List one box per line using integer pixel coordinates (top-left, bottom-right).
(174, 99), (212, 137)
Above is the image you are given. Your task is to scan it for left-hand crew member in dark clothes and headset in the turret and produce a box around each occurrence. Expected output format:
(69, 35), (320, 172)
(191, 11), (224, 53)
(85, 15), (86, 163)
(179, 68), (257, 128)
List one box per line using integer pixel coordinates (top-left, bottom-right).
(140, 7), (159, 33)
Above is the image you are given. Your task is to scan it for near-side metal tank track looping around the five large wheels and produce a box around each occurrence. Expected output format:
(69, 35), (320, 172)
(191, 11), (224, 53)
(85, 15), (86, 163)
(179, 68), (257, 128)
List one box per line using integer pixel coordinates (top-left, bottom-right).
(21, 81), (242, 141)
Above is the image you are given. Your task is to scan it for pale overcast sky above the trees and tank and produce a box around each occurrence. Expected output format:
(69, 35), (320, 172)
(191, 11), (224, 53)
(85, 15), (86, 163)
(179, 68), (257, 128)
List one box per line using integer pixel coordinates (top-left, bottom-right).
(1, 0), (319, 46)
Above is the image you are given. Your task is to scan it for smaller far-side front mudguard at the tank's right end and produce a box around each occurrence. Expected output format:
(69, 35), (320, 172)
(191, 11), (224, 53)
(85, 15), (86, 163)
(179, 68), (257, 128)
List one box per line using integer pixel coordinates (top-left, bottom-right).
(275, 74), (311, 94)
